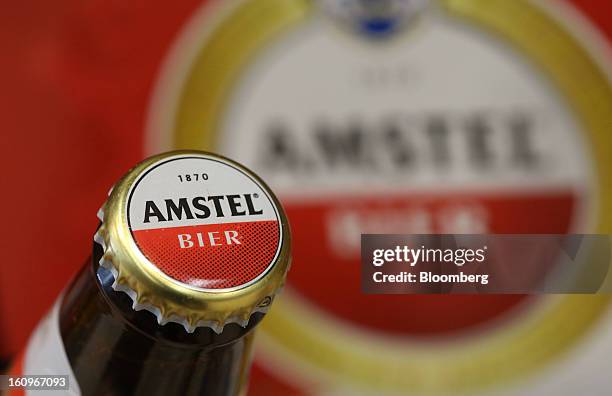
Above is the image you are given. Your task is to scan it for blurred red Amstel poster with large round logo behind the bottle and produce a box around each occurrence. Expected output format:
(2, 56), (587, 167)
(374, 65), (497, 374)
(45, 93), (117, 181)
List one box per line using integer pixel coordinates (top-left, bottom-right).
(0, 0), (612, 395)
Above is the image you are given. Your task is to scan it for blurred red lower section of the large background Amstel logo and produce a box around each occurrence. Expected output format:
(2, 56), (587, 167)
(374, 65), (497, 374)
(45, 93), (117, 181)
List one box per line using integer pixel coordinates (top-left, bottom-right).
(285, 190), (579, 337)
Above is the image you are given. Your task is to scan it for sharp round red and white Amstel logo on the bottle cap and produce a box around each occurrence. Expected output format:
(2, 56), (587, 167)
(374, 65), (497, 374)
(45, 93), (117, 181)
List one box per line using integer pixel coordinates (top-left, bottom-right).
(127, 154), (282, 291)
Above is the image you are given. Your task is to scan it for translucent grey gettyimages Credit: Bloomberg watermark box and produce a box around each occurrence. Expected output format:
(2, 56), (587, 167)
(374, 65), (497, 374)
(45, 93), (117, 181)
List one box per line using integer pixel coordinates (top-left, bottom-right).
(361, 234), (612, 294)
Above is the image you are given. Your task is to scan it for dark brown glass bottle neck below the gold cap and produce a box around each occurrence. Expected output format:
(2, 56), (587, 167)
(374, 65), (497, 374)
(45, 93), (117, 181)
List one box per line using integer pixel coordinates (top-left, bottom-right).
(60, 245), (263, 395)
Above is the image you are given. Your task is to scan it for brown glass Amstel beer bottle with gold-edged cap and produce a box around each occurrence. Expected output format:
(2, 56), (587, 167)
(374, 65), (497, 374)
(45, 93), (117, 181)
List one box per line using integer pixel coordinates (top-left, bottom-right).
(11, 151), (290, 396)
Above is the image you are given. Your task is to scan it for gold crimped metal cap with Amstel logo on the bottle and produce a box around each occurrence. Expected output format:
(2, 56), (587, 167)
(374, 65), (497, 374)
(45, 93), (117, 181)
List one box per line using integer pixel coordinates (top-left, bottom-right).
(94, 151), (290, 333)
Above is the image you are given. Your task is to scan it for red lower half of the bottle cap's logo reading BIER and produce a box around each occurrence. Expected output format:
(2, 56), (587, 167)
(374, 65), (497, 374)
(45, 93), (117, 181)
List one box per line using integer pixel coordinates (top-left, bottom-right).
(133, 221), (280, 289)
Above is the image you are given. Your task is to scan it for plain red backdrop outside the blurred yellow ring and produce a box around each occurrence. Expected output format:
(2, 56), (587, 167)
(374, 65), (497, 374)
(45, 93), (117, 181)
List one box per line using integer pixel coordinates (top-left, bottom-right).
(0, 0), (612, 392)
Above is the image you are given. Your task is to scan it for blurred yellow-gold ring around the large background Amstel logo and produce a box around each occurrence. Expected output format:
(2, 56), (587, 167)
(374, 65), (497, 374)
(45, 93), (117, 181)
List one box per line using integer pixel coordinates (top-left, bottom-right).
(174, 0), (612, 393)
